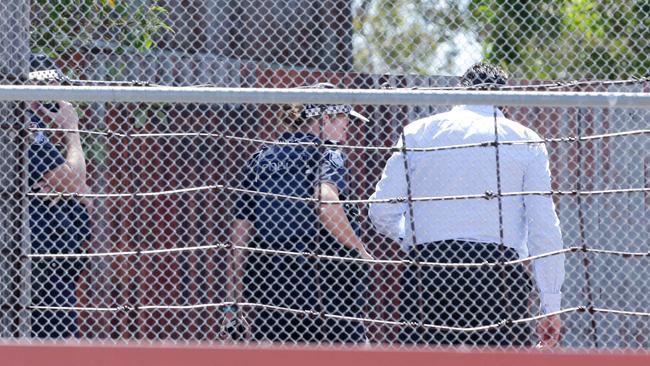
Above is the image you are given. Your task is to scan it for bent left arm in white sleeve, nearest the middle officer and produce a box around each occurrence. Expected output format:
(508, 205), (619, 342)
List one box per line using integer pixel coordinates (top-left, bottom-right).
(368, 142), (408, 242)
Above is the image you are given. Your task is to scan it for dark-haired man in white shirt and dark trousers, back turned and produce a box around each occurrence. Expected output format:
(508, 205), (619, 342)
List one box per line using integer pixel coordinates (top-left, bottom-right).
(369, 63), (564, 347)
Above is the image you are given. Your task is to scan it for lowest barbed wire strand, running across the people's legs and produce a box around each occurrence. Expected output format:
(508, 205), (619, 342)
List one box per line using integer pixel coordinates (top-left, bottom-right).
(21, 301), (650, 332)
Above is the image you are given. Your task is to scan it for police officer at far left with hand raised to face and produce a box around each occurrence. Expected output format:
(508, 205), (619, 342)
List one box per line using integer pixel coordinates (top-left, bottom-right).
(27, 55), (90, 338)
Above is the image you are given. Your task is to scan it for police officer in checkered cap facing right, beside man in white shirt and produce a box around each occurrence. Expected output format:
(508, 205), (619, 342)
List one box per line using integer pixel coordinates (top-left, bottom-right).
(224, 83), (372, 343)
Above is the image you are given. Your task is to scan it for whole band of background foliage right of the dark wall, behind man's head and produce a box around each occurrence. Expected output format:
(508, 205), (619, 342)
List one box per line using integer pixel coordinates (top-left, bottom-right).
(353, 0), (650, 80)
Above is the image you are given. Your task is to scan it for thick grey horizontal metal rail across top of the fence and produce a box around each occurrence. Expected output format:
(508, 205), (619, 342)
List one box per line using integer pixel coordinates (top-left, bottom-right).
(0, 85), (650, 108)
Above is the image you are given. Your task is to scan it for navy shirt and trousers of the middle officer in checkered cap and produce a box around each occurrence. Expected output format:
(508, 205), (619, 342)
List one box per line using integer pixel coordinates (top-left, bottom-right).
(234, 133), (365, 343)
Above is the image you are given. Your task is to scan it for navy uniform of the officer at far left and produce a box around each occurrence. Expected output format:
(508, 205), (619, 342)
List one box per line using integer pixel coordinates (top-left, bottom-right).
(28, 114), (90, 338)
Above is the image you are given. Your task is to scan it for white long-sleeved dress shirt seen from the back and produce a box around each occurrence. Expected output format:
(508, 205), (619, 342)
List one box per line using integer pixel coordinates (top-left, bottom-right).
(369, 106), (564, 313)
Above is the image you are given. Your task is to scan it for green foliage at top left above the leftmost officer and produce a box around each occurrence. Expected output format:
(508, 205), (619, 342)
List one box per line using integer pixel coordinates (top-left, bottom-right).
(31, 0), (173, 57)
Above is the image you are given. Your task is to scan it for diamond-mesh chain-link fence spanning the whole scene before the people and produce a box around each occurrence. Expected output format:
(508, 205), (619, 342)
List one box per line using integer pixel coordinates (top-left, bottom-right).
(0, 0), (650, 349)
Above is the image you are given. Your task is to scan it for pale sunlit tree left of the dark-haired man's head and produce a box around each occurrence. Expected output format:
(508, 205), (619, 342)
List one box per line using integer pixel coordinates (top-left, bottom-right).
(353, 0), (467, 74)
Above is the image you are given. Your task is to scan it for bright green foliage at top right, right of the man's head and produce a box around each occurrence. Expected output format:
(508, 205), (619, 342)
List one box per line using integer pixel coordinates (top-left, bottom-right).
(469, 0), (650, 80)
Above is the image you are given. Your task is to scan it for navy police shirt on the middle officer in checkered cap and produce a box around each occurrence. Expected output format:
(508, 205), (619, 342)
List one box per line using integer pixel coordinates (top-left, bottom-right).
(234, 132), (359, 250)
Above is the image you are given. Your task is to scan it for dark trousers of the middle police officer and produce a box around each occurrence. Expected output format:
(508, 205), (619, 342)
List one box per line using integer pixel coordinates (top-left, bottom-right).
(244, 242), (367, 343)
